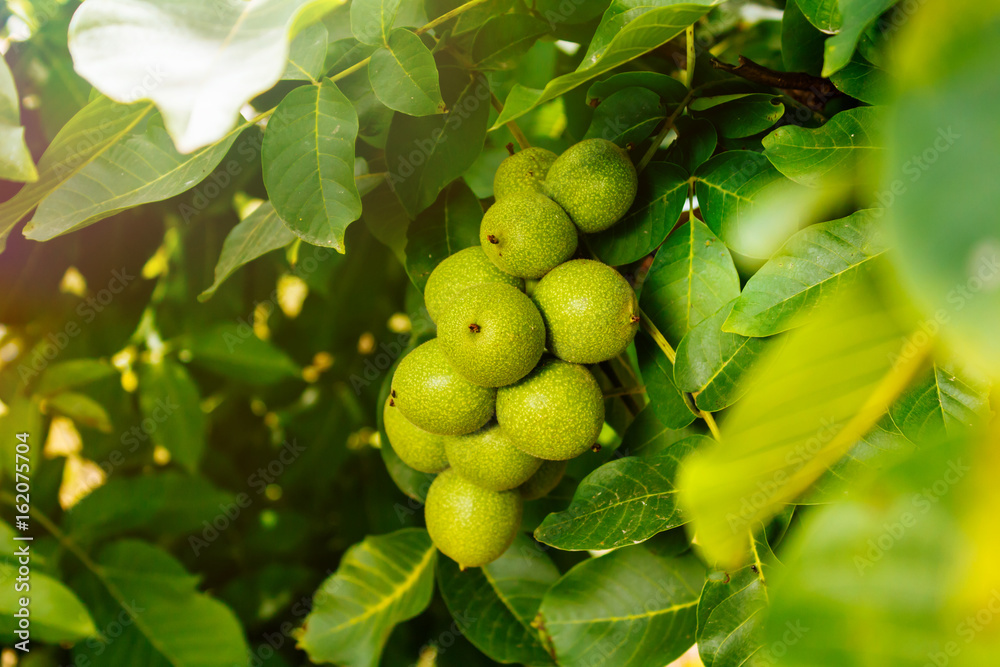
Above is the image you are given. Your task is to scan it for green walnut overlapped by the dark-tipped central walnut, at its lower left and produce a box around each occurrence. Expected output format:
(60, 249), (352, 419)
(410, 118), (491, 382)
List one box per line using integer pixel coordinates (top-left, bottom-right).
(389, 338), (496, 435)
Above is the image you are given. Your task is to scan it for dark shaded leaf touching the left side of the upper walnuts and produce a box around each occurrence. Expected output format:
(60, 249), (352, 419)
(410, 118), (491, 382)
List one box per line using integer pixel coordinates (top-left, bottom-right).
(406, 180), (483, 292)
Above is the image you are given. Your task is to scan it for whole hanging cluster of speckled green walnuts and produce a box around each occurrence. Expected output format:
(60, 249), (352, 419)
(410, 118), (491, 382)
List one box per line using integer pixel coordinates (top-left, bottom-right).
(383, 139), (639, 568)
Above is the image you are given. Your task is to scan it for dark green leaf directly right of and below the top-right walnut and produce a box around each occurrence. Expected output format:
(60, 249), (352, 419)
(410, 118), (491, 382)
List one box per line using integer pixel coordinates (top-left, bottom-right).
(584, 162), (688, 266)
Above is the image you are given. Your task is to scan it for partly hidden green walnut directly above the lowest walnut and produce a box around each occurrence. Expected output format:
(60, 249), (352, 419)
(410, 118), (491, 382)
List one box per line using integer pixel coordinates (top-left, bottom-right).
(445, 423), (542, 491)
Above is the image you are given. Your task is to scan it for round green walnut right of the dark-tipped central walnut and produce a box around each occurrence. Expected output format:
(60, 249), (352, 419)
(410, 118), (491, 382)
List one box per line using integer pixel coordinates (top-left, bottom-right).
(532, 259), (639, 364)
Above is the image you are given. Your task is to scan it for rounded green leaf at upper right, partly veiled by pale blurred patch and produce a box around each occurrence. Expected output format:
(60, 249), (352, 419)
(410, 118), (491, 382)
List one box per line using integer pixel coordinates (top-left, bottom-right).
(695, 151), (808, 259)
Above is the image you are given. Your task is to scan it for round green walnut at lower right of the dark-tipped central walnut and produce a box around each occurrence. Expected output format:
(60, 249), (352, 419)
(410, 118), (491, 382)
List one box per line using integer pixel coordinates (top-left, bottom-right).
(497, 358), (604, 461)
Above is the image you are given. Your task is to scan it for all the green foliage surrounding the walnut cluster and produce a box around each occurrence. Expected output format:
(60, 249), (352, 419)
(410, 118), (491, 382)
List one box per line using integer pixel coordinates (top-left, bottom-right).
(0, 0), (1000, 667)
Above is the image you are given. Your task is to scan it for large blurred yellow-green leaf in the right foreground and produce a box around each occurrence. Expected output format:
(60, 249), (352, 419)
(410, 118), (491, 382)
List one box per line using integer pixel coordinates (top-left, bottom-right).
(678, 283), (921, 563)
